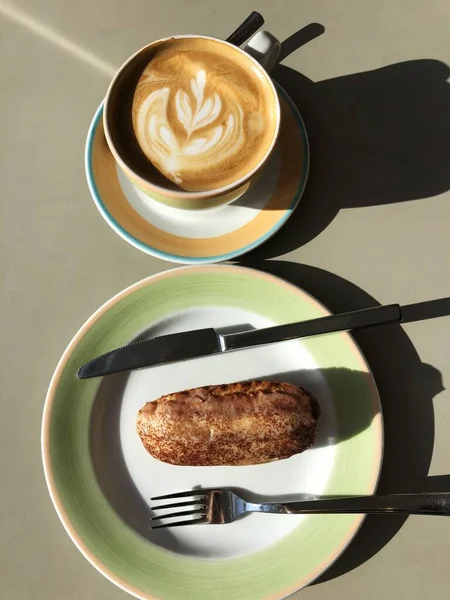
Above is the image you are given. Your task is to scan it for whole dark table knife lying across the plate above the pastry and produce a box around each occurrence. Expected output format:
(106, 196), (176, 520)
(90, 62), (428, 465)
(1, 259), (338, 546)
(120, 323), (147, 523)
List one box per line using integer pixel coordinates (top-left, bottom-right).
(77, 304), (402, 379)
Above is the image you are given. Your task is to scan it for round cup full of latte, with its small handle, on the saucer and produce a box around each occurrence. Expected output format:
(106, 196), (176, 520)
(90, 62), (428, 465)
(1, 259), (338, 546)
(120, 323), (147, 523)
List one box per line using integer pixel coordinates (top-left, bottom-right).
(103, 32), (280, 209)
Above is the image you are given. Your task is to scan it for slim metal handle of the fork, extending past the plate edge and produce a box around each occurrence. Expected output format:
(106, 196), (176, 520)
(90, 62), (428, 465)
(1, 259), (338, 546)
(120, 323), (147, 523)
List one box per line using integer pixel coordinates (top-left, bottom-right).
(247, 492), (450, 517)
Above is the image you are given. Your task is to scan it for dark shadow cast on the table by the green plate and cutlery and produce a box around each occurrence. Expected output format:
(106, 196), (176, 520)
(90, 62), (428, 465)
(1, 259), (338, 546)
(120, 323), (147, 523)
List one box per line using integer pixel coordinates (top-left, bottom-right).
(246, 260), (450, 584)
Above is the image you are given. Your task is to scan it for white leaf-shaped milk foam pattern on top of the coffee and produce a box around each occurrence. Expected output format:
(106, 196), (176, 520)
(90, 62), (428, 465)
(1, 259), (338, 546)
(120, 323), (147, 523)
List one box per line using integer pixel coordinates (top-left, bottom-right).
(135, 69), (245, 185)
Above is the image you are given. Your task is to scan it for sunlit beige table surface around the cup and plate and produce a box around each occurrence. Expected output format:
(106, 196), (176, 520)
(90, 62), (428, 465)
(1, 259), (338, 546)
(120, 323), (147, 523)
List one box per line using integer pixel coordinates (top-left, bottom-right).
(0, 0), (450, 600)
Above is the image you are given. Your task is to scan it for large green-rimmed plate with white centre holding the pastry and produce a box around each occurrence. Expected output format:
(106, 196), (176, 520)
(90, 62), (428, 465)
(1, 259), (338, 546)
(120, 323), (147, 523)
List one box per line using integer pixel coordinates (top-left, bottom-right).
(42, 266), (383, 600)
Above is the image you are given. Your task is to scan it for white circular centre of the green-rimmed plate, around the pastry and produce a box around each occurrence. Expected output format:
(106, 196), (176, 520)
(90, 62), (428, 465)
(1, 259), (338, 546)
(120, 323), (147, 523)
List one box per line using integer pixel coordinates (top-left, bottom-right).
(92, 307), (336, 559)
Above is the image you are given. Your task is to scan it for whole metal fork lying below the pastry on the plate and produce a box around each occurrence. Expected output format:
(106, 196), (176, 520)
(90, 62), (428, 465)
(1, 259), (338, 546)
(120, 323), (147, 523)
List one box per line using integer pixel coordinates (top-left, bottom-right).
(151, 488), (450, 529)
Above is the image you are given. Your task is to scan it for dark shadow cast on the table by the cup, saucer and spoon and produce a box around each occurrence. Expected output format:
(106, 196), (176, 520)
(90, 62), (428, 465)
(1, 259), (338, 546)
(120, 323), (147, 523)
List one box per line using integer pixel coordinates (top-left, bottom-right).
(250, 23), (450, 258)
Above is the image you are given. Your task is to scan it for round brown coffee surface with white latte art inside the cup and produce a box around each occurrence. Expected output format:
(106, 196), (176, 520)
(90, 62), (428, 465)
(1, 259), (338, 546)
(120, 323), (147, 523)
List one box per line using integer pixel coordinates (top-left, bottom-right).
(133, 39), (273, 190)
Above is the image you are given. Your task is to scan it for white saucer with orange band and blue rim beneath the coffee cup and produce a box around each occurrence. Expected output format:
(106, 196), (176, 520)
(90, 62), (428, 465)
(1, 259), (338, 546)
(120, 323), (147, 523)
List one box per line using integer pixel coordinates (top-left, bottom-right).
(85, 85), (309, 264)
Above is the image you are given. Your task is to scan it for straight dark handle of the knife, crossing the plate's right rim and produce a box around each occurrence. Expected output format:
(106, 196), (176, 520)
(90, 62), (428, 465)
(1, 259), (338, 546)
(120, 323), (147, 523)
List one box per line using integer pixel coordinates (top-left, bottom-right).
(221, 304), (402, 350)
